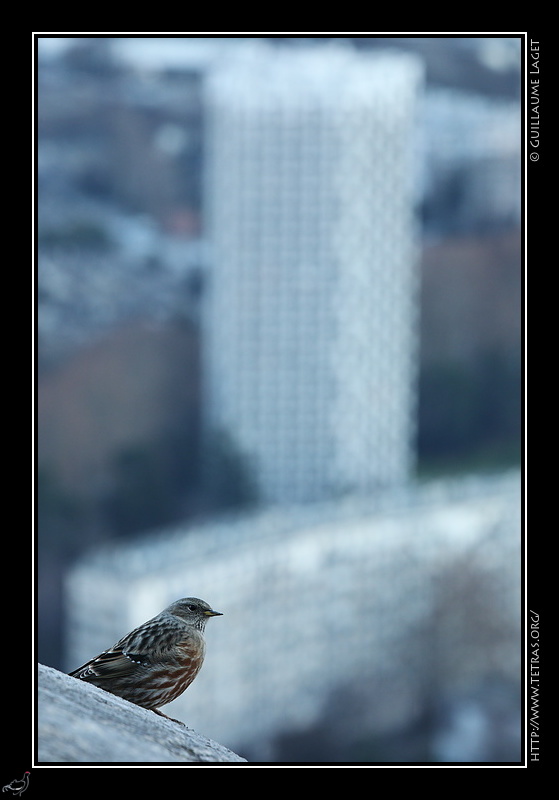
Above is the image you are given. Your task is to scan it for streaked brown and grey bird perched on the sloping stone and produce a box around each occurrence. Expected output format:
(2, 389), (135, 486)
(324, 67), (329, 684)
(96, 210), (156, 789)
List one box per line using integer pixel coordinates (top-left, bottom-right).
(68, 597), (222, 724)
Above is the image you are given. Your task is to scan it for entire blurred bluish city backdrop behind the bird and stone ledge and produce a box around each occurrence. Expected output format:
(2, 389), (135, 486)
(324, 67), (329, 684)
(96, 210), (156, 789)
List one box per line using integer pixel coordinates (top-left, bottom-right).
(36, 36), (522, 763)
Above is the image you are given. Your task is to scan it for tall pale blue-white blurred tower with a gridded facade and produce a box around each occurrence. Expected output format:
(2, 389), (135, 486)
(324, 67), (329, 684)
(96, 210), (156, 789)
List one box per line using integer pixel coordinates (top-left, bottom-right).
(204, 49), (422, 503)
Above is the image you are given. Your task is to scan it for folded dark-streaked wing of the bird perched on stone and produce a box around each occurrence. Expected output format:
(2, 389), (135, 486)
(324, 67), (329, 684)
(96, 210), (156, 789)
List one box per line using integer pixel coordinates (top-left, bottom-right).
(69, 617), (199, 681)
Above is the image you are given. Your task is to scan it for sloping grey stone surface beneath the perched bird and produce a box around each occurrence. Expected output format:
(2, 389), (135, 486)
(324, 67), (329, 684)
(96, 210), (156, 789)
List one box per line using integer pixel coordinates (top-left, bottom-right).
(38, 664), (246, 764)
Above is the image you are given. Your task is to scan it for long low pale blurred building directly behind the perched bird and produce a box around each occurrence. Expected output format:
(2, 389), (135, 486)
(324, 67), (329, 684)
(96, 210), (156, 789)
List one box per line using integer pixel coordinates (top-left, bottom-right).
(67, 472), (521, 762)
